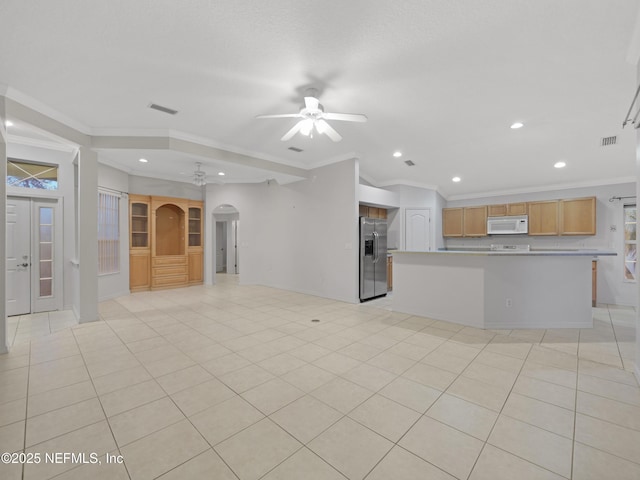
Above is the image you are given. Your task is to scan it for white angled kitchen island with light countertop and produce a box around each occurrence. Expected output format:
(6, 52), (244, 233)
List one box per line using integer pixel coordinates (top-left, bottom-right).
(392, 250), (616, 329)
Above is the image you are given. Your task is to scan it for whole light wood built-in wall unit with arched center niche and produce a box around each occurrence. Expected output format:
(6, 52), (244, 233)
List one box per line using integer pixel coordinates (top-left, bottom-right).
(129, 195), (203, 291)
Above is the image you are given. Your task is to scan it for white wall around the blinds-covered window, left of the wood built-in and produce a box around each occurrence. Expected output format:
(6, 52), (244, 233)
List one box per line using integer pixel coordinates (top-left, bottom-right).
(98, 164), (129, 301)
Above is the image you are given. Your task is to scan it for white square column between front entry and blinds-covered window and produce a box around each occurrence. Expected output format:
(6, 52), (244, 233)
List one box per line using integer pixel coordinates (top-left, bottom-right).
(75, 147), (99, 323)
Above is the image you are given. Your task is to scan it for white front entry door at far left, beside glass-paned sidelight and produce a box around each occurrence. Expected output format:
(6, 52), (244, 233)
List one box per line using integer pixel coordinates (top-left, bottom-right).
(6, 197), (31, 316)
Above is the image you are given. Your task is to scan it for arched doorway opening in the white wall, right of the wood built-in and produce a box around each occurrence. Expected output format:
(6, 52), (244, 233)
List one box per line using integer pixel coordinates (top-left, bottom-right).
(213, 204), (240, 275)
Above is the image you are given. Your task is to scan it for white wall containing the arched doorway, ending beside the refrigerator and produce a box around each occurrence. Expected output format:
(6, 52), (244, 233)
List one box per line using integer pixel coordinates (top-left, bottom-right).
(205, 160), (358, 302)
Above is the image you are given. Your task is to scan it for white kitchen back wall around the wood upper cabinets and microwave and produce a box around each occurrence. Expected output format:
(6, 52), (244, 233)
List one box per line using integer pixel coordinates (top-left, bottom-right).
(446, 183), (638, 305)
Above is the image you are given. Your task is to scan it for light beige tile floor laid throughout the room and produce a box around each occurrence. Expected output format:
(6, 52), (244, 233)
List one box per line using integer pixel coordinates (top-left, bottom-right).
(0, 275), (640, 480)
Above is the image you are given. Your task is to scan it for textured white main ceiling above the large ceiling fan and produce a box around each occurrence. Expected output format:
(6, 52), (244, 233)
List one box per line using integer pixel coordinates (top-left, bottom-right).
(0, 0), (639, 198)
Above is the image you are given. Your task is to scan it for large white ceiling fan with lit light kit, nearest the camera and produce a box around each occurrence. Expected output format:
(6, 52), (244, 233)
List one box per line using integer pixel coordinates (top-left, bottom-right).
(256, 88), (367, 142)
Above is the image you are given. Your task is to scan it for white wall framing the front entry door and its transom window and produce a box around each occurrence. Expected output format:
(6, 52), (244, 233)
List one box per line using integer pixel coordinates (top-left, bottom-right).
(7, 143), (77, 309)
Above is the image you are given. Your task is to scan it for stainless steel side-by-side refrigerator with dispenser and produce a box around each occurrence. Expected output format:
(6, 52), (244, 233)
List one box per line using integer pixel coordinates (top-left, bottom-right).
(360, 217), (387, 302)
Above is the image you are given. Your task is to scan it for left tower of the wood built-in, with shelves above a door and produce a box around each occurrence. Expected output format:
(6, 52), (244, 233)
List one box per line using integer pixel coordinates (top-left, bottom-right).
(129, 195), (151, 292)
